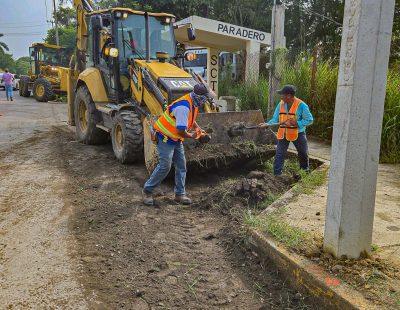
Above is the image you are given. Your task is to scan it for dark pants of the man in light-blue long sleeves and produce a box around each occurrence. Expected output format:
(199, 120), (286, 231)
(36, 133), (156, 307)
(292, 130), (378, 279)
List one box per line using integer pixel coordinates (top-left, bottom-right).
(274, 132), (310, 175)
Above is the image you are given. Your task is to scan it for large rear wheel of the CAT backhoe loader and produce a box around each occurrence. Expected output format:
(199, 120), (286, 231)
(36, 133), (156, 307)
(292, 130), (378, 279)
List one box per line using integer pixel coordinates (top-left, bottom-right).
(74, 86), (109, 144)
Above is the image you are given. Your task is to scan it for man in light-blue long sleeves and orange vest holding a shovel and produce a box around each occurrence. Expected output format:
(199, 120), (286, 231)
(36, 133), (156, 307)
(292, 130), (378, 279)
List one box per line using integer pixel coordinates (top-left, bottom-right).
(260, 85), (313, 176)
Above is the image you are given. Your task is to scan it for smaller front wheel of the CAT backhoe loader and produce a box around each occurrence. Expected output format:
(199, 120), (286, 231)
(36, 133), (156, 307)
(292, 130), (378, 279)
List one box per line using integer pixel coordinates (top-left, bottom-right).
(111, 110), (144, 164)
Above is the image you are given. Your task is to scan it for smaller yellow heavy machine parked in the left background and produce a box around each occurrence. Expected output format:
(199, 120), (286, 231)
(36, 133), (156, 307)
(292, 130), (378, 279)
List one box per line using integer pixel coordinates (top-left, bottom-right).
(19, 43), (69, 102)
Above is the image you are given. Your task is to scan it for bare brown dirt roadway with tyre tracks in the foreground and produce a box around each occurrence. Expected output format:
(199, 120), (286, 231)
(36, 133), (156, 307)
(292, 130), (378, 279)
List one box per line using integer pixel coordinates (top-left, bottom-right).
(0, 127), (317, 309)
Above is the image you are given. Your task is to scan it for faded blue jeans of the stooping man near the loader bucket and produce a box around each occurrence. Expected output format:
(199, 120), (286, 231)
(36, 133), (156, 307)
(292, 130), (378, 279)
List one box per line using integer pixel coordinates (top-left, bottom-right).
(144, 140), (186, 195)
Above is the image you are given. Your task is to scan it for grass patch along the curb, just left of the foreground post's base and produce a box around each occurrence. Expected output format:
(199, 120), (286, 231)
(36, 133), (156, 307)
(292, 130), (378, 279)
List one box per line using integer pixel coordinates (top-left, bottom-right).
(244, 208), (310, 250)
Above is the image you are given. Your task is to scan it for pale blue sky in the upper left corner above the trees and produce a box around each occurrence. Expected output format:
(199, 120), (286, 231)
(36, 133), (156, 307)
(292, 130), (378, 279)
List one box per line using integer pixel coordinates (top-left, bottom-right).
(0, 0), (57, 59)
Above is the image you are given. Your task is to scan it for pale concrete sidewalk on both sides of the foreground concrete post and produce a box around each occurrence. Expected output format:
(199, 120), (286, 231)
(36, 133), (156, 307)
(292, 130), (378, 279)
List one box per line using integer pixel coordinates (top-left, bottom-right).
(285, 139), (400, 266)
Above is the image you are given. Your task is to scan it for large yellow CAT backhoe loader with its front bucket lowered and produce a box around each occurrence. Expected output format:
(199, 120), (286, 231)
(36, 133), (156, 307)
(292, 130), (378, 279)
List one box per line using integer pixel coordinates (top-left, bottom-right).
(68, 0), (276, 171)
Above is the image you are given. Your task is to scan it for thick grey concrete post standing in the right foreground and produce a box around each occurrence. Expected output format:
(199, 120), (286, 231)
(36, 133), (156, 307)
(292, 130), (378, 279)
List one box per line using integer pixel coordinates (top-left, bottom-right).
(324, 0), (394, 258)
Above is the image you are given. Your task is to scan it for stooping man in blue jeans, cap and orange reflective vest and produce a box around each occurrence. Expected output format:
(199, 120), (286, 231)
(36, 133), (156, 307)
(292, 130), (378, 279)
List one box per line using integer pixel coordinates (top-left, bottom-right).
(142, 84), (208, 206)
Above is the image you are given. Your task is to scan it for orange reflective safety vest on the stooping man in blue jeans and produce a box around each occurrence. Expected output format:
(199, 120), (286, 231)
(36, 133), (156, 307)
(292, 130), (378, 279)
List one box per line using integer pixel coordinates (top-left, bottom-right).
(154, 94), (199, 142)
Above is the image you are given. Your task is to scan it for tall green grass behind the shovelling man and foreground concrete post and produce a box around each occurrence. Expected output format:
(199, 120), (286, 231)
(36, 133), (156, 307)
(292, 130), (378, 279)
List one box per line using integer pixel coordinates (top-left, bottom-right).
(220, 52), (400, 163)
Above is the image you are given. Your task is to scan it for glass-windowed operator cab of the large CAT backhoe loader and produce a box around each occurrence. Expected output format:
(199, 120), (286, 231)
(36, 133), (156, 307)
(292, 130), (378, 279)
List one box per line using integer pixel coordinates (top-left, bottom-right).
(86, 9), (176, 103)
